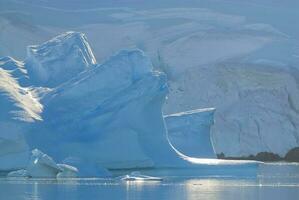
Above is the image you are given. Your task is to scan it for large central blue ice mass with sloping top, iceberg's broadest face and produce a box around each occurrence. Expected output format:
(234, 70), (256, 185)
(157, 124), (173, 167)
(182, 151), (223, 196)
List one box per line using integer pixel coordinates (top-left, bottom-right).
(27, 50), (180, 169)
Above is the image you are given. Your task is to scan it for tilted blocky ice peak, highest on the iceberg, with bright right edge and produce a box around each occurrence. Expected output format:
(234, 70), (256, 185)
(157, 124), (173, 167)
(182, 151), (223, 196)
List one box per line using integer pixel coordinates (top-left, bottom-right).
(26, 32), (96, 87)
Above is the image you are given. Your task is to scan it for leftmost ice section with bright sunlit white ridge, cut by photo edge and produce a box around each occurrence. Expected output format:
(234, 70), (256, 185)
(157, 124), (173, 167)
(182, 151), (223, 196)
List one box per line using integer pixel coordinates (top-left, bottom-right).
(0, 57), (43, 170)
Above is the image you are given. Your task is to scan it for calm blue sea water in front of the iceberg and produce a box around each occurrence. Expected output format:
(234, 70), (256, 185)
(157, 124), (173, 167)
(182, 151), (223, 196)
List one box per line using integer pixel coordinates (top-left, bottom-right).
(0, 164), (299, 200)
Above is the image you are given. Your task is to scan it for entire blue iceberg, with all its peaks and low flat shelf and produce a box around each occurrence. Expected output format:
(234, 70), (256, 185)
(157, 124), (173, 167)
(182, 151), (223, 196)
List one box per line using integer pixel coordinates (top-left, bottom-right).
(0, 32), (262, 178)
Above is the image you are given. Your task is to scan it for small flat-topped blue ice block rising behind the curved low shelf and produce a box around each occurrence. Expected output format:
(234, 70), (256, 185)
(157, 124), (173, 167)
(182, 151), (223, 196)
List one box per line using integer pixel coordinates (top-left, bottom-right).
(164, 108), (216, 158)
